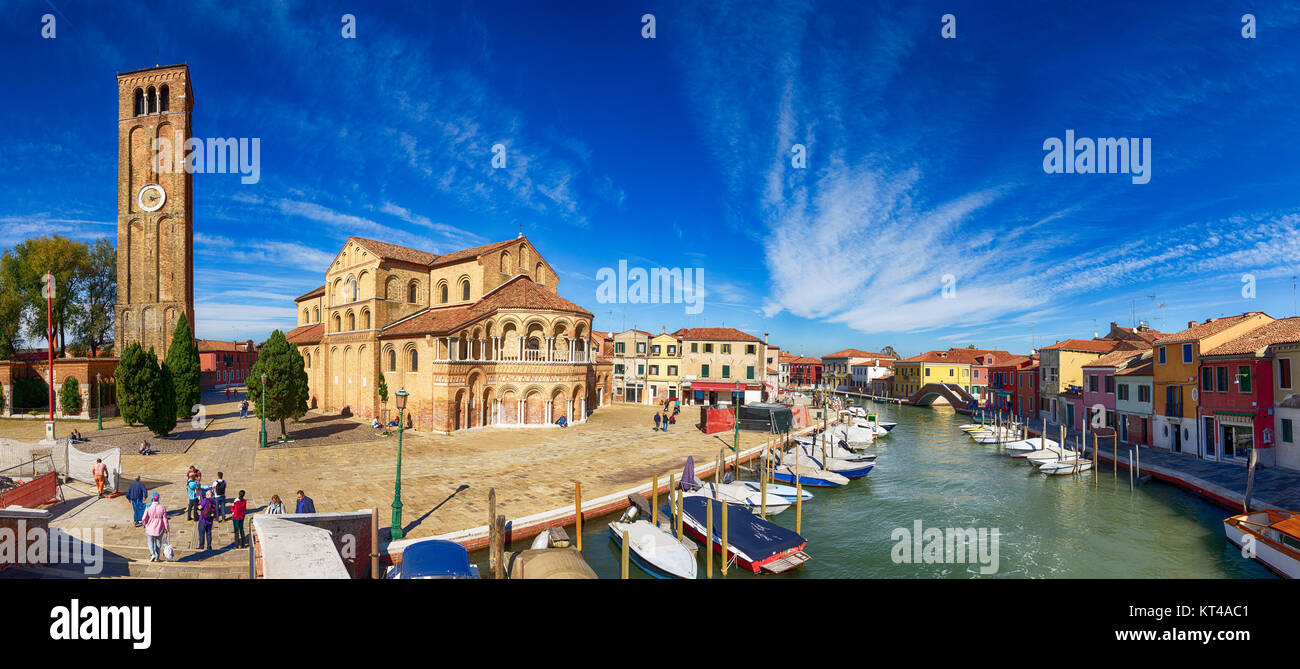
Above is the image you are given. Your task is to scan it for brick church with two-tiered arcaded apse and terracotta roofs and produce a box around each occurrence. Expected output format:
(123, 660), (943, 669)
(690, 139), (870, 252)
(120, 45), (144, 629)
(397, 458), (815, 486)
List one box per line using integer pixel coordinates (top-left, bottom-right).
(286, 236), (610, 431)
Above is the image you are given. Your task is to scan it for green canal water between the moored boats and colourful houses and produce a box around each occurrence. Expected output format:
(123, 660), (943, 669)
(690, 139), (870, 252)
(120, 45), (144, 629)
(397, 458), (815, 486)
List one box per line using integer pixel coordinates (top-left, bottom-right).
(473, 401), (1273, 578)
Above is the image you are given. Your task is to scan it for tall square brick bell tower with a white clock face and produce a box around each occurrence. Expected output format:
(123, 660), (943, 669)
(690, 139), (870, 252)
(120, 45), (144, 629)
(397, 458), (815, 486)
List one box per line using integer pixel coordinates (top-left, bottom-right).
(114, 65), (194, 359)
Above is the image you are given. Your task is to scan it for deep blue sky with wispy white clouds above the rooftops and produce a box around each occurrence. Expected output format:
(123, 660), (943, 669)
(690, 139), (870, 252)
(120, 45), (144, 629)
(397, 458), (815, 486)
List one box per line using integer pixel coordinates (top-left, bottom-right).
(0, 0), (1300, 355)
